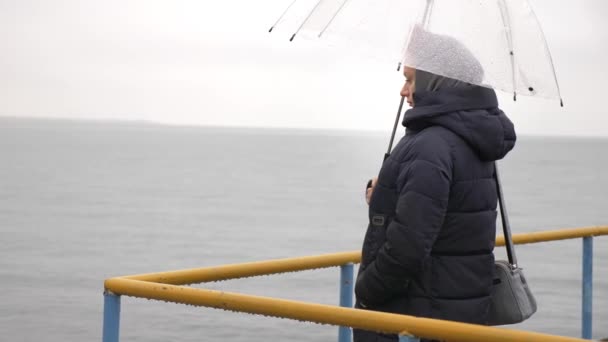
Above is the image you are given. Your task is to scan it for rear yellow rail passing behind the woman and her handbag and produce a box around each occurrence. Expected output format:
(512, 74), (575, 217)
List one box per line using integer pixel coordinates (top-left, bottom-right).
(117, 226), (608, 285)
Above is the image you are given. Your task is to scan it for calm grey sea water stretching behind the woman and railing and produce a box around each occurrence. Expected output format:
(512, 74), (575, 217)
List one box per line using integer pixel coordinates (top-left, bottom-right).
(0, 118), (608, 342)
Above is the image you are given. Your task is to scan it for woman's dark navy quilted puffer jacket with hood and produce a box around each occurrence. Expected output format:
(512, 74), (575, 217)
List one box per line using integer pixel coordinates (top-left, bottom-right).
(355, 86), (515, 324)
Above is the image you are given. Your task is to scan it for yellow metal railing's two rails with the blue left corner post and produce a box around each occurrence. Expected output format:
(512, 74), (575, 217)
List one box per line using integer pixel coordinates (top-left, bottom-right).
(104, 226), (608, 342)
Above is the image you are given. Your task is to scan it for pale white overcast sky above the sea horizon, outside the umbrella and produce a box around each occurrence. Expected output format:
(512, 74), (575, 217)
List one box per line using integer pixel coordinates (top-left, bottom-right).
(0, 0), (608, 136)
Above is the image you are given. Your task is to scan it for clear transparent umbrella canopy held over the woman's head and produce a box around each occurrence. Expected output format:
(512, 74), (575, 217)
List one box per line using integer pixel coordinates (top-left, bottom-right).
(273, 0), (561, 101)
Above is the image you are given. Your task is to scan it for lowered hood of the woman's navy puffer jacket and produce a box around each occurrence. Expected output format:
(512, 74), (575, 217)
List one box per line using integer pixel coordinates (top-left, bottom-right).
(403, 86), (516, 161)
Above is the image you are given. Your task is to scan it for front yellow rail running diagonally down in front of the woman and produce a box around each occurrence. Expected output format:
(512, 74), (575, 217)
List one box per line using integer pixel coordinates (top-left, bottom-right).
(106, 278), (586, 342)
